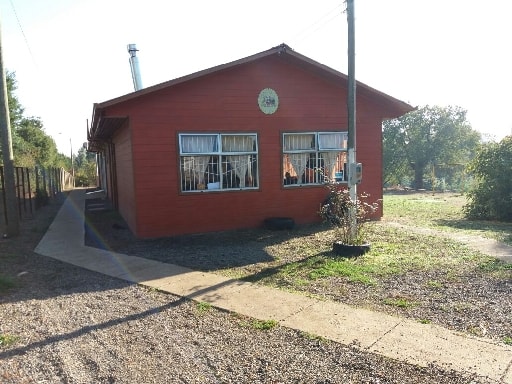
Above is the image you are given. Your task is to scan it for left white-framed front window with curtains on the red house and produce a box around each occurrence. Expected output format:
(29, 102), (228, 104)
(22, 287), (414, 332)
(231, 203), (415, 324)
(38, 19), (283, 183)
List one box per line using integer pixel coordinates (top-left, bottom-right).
(179, 133), (259, 192)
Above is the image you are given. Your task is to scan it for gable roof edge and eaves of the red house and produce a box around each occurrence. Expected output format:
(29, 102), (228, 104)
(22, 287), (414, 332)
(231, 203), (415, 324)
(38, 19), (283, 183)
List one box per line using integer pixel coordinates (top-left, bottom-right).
(87, 43), (415, 151)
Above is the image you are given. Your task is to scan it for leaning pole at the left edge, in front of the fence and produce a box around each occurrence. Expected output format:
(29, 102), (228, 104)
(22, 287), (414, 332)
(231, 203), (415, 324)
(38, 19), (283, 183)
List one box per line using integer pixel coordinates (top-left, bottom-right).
(0, 21), (20, 237)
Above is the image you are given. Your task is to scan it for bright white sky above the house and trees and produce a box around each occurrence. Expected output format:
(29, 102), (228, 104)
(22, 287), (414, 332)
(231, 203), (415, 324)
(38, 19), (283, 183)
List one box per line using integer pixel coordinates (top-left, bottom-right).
(0, 0), (512, 155)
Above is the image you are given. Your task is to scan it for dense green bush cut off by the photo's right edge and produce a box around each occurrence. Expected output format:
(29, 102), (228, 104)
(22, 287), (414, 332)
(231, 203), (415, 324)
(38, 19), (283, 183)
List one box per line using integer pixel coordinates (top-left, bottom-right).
(464, 136), (512, 222)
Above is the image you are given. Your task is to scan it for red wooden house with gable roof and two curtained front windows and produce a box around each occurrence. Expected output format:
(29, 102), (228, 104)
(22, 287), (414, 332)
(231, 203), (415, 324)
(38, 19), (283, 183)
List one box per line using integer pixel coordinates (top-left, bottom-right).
(88, 44), (413, 238)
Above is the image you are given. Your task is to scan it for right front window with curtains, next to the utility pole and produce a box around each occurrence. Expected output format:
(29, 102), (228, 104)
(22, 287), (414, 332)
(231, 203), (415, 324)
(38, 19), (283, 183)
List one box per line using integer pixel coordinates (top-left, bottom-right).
(283, 132), (348, 187)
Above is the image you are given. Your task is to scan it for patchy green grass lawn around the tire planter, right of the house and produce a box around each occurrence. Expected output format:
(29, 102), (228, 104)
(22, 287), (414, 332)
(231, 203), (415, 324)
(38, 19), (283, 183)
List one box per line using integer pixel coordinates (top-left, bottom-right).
(237, 194), (512, 289)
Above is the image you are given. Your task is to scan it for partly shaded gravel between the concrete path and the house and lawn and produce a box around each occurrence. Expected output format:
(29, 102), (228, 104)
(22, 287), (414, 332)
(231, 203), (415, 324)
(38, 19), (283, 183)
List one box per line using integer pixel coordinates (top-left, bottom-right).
(85, 194), (512, 342)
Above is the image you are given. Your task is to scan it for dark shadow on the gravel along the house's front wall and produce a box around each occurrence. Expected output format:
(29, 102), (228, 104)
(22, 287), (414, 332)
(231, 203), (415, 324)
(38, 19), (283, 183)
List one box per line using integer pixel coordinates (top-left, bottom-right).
(85, 200), (326, 271)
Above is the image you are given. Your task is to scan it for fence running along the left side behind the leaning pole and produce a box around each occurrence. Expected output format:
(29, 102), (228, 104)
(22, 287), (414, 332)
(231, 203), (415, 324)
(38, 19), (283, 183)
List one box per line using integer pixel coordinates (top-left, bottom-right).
(0, 166), (74, 228)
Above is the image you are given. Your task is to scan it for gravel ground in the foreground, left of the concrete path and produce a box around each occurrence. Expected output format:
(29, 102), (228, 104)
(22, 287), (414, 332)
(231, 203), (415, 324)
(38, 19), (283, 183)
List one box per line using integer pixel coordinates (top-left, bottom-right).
(0, 194), (502, 383)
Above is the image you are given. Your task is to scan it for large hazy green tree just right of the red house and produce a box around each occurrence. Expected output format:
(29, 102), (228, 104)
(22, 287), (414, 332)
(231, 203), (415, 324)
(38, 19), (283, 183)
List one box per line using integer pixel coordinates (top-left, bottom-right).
(383, 106), (481, 189)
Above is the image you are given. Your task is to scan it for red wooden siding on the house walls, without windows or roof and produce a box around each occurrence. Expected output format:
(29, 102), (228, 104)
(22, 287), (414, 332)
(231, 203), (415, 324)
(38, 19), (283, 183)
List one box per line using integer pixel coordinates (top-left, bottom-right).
(104, 56), (390, 238)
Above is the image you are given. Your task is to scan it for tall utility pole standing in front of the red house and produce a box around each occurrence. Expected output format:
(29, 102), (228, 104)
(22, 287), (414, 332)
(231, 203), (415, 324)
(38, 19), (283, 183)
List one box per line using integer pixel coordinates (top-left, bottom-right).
(347, 0), (357, 234)
